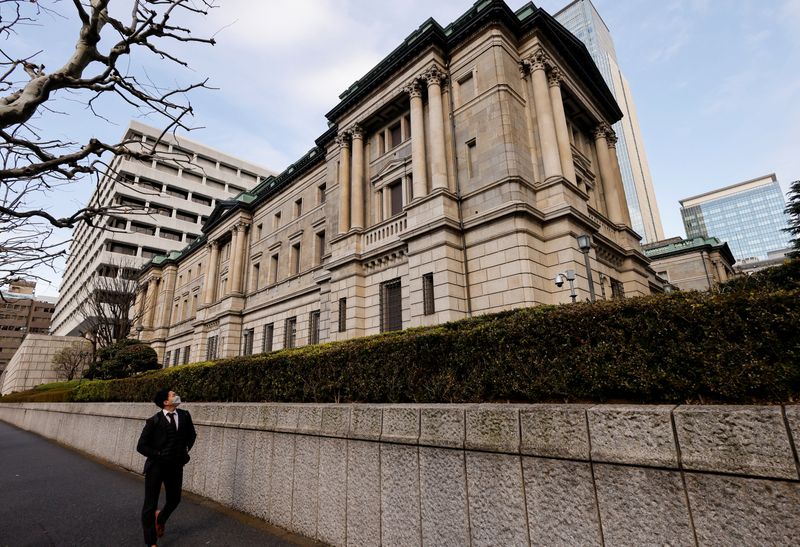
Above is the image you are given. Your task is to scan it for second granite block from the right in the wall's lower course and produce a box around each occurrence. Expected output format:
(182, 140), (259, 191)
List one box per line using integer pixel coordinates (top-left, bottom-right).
(594, 464), (694, 547)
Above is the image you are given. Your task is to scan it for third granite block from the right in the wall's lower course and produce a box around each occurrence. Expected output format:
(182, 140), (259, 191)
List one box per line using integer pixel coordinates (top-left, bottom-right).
(522, 457), (603, 547)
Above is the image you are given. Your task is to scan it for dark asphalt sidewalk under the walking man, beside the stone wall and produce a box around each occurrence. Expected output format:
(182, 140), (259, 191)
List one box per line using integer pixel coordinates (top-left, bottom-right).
(0, 422), (320, 547)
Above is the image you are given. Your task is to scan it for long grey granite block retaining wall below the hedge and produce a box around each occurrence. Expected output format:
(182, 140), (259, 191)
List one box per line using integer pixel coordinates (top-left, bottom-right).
(0, 403), (800, 546)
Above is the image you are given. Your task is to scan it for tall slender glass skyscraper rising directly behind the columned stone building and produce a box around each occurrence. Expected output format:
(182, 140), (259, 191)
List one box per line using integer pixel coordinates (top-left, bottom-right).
(555, 0), (664, 242)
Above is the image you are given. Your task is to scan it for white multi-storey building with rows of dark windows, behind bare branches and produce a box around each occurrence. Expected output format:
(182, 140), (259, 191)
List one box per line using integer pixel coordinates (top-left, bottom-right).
(51, 121), (271, 336)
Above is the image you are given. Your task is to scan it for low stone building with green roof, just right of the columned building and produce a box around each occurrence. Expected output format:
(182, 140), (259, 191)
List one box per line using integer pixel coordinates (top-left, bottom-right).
(642, 237), (736, 291)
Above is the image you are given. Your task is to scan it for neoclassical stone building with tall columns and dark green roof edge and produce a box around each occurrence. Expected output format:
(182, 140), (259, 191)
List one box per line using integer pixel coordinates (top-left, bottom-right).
(137, 0), (657, 364)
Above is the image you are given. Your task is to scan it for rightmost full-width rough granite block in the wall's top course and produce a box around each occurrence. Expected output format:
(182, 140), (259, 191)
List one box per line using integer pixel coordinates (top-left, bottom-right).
(675, 406), (798, 480)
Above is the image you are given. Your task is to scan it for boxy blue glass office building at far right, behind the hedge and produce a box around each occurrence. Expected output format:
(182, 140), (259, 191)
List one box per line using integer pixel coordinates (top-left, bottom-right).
(680, 173), (791, 266)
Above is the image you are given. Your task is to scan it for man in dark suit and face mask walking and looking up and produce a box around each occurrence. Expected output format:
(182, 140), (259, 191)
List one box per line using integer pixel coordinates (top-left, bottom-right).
(136, 389), (197, 547)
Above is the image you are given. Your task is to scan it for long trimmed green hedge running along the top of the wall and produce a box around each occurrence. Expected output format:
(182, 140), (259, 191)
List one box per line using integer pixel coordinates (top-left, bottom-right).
(64, 290), (800, 403)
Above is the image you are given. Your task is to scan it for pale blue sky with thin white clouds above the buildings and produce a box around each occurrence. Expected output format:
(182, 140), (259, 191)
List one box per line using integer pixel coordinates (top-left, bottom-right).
(9, 0), (800, 295)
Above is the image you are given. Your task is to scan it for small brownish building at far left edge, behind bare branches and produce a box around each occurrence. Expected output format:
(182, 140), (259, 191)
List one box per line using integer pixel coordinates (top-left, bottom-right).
(0, 279), (56, 374)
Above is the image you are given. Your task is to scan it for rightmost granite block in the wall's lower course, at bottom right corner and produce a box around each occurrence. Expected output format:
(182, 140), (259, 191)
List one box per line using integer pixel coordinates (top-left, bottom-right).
(686, 473), (800, 547)
